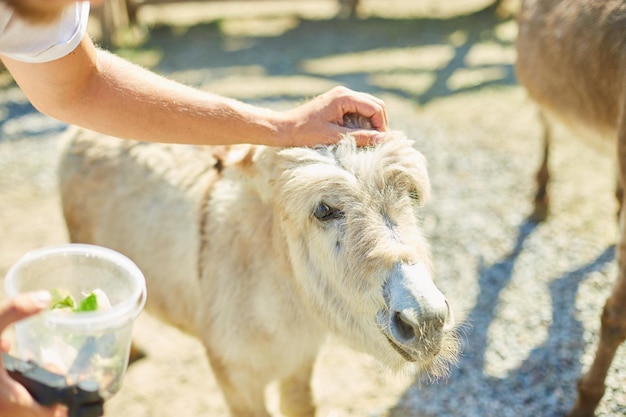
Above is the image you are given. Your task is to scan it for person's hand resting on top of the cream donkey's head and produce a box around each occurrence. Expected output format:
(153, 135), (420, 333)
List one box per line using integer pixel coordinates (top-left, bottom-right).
(281, 87), (388, 146)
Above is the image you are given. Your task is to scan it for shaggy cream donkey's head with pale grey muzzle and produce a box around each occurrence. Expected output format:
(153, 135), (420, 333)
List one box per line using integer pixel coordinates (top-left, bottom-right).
(250, 134), (457, 376)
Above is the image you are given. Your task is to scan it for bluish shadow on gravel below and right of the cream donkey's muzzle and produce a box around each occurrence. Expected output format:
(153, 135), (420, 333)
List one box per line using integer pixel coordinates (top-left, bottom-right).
(388, 221), (615, 417)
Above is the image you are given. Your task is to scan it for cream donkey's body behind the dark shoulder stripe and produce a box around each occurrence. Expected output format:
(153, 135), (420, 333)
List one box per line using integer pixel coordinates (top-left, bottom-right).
(59, 130), (219, 333)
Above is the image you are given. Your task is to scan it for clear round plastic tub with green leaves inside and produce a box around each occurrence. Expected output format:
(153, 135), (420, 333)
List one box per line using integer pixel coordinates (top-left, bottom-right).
(4, 244), (147, 399)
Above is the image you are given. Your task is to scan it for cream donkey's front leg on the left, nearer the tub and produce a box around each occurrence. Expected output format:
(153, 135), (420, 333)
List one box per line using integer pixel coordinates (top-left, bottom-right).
(209, 356), (270, 417)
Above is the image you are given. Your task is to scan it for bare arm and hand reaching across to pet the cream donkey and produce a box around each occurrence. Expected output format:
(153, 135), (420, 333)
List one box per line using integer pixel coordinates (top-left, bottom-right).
(2, 35), (387, 146)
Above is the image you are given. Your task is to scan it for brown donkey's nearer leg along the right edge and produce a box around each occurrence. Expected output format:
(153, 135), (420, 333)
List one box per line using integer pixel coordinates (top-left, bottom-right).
(569, 125), (626, 417)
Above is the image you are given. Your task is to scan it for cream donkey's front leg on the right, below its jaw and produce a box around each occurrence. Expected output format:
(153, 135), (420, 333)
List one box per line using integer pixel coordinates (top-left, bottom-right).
(280, 361), (315, 417)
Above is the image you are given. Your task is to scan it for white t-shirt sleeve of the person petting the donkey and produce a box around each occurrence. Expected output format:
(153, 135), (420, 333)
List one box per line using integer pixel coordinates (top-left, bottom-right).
(0, 1), (89, 63)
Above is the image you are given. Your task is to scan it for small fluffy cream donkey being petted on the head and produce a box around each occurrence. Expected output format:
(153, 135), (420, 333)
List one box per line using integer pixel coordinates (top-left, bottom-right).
(59, 122), (459, 417)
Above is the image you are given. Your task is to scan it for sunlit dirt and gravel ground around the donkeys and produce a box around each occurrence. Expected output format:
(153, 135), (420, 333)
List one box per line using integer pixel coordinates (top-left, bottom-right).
(0, 0), (626, 417)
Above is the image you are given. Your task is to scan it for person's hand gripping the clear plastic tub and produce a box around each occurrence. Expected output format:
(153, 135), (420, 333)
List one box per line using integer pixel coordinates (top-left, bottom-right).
(0, 291), (67, 417)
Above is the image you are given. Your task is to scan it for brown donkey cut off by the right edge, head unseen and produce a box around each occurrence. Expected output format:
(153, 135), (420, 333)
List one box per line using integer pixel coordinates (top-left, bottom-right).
(516, 0), (626, 417)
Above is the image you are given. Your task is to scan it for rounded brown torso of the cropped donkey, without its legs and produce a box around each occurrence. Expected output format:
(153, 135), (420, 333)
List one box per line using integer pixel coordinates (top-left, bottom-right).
(516, 0), (626, 138)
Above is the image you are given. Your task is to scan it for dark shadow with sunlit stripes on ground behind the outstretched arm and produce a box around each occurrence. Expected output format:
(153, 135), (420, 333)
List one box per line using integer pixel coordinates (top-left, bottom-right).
(116, 1), (516, 104)
